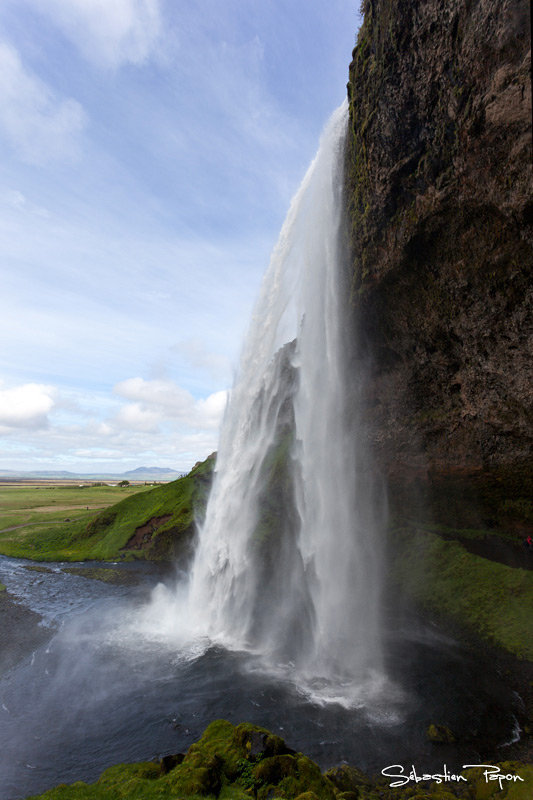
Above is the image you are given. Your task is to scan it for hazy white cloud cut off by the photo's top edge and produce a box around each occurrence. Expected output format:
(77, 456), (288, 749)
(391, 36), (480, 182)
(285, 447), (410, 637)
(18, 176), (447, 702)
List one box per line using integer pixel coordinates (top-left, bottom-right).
(29, 0), (163, 68)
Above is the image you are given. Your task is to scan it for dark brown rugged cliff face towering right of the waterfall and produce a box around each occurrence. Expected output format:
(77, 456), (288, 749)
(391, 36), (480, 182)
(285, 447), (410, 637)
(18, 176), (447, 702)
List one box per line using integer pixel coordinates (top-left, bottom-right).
(346, 0), (533, 531)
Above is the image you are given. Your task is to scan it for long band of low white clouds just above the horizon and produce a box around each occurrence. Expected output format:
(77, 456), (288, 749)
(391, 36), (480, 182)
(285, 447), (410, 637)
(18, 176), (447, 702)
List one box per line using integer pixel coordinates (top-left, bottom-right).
(0, 378), (222, 472)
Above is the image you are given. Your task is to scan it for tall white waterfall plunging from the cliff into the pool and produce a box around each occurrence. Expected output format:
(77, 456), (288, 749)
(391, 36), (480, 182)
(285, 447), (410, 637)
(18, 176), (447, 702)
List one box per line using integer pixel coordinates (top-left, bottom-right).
(164, 104), (382, 702)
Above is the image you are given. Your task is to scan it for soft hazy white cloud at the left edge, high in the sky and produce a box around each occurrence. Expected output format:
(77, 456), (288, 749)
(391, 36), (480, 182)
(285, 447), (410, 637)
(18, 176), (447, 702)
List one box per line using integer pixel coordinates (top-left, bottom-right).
(0, 42), (86, 166)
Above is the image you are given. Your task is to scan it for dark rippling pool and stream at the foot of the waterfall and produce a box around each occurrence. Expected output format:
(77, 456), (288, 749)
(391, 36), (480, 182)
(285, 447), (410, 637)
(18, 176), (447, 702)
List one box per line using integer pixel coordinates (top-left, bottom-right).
(0, 557), (516, 800)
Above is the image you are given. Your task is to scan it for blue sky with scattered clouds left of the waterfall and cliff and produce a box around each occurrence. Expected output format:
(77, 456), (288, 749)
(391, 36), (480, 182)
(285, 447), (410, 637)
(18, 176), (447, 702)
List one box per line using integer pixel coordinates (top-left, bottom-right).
(0, 0), (361, 473)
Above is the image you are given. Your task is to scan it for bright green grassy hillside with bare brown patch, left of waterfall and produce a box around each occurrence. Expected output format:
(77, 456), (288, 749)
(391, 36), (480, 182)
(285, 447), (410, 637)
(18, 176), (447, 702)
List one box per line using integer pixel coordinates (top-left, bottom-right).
(0, 456), (215, 561)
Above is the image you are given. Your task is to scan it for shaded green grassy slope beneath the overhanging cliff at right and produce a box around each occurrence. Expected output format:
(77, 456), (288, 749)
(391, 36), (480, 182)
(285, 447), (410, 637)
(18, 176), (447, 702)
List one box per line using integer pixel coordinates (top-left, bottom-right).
(393, 528), (533, 660)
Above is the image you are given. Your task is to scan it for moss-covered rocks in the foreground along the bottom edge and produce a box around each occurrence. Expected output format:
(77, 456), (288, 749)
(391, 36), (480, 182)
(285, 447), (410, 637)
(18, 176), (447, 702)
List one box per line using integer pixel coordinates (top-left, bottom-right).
(25, 720), (533, 800)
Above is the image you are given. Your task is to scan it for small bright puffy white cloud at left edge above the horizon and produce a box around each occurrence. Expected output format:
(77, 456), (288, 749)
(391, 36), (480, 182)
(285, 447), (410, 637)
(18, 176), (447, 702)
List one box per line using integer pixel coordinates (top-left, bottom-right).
(0, 383), (55, 432)
